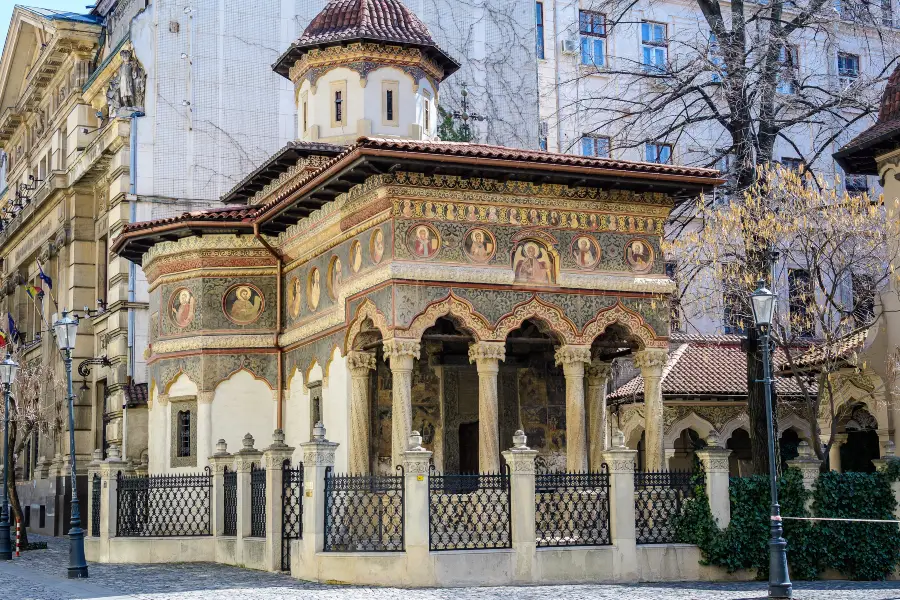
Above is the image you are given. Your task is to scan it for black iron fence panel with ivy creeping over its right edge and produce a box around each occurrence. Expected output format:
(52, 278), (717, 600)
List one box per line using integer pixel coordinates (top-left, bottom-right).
(634, 471), (695, 544)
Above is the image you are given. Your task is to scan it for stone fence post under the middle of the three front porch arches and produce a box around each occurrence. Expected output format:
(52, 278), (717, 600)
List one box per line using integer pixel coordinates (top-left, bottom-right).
(503, 429), (538, 583)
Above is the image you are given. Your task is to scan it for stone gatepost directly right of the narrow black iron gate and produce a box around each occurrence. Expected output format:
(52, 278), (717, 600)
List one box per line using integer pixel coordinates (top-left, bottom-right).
(291, 422), (338, 581)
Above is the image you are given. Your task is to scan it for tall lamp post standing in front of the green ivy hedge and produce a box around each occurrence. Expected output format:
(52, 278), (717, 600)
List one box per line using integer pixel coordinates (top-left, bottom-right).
(750, 282), (793, 598)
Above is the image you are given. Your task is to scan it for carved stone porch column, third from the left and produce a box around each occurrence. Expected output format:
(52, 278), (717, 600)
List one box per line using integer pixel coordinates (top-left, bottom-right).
(469, 342), (506, 473)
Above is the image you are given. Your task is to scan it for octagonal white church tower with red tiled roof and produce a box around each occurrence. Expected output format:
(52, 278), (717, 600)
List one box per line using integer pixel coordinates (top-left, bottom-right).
(273, 0), (459, 144)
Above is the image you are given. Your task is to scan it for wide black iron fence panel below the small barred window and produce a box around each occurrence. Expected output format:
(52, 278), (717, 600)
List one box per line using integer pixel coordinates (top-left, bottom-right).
(116, 467), (212, 537)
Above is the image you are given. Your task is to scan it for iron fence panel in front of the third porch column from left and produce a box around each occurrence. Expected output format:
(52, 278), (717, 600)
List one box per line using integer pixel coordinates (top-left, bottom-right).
(428, 465), (512, 550)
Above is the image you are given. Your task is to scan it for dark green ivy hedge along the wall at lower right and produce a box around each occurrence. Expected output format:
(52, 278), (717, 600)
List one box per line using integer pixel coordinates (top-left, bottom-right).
(675, 461), (900, 580)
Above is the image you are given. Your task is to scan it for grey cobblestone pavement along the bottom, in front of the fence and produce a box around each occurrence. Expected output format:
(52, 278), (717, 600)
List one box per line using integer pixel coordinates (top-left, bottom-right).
(0, 536), (900, 600)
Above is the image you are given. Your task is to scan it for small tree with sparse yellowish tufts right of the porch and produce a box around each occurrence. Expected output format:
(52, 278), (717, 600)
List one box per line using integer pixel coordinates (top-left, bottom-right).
(667, 166), (900, 471)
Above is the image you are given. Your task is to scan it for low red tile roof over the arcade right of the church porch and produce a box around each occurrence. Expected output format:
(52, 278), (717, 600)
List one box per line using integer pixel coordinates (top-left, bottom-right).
(608, 336), (815, 400)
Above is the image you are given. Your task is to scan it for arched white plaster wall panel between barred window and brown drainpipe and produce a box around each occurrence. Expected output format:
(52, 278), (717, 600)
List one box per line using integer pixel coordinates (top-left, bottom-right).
(211, 371), (275, 453)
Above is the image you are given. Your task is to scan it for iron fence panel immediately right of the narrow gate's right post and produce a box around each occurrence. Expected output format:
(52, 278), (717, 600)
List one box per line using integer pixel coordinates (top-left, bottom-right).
(325, 466), (404, 552)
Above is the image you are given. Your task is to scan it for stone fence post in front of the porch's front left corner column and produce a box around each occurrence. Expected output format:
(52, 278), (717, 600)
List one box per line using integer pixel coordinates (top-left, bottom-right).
(403, 431), (434, 586)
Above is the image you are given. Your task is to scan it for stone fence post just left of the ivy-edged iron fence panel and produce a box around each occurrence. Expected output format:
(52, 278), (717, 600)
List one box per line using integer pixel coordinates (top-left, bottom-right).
(603, 430), (638, 581)
